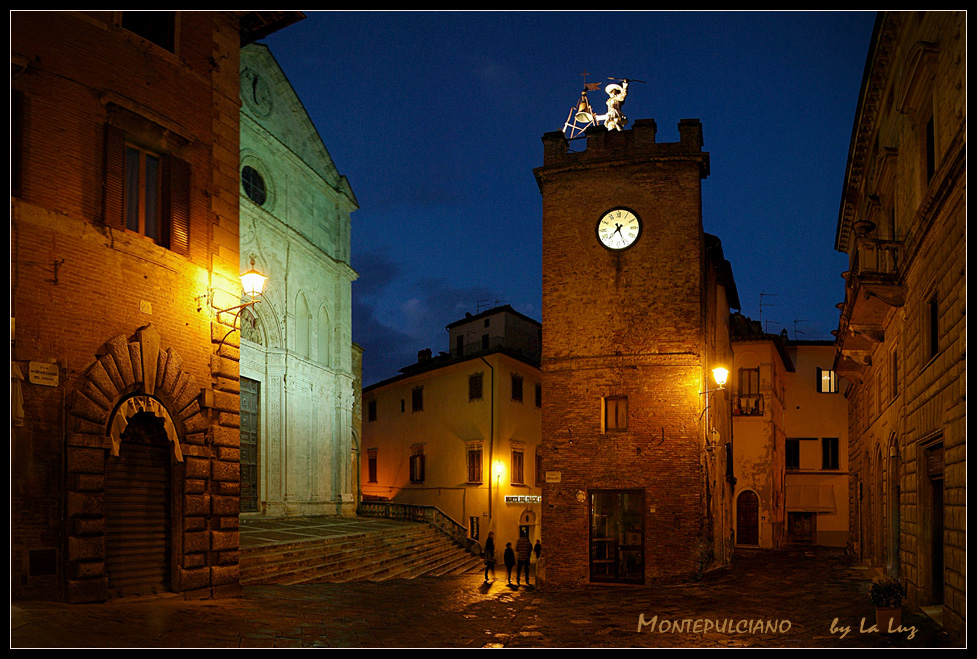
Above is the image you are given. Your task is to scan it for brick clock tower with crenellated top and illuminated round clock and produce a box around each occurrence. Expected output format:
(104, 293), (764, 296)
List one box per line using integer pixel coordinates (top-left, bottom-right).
(535, 119), (739, 585)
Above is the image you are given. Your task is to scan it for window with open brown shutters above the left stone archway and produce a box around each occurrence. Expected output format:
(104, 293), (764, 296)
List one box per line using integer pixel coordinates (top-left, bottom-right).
(103, 124), (190, 255)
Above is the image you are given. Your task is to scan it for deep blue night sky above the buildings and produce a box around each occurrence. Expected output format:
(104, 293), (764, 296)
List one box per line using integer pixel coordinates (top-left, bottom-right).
(265, 11), (875, 385)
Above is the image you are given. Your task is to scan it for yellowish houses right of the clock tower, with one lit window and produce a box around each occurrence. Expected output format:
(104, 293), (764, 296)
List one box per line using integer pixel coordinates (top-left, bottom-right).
(729, 314), (848, 549)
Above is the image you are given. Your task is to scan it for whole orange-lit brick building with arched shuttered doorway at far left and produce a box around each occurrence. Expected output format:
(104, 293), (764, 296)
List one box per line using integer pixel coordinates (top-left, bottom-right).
(10, 11), (301, 602)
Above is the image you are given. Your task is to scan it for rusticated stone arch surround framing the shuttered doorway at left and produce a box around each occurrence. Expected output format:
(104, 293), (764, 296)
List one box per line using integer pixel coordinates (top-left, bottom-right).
(65, 325), (211, 602)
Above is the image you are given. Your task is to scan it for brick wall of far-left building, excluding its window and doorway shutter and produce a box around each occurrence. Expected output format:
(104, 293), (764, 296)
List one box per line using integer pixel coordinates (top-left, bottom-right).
(11, 12), (240, 601)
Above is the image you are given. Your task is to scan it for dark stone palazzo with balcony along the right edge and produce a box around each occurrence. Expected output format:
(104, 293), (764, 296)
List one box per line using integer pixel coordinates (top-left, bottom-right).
(835, 7), (967, 639)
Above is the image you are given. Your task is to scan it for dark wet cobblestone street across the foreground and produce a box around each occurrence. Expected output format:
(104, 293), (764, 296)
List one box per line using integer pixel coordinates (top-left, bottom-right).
(11, 549), (954, 648)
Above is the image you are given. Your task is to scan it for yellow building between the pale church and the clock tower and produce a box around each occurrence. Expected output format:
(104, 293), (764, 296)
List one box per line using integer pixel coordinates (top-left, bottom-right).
(360, 306), (542, 556)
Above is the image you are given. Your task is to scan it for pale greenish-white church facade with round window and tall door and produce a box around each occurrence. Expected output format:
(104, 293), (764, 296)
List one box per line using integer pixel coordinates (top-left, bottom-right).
(240, 44), (358, 516)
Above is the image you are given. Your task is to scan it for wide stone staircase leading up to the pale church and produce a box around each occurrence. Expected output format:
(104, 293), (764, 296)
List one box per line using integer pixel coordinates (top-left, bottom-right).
(239, 523), (482, 586)
